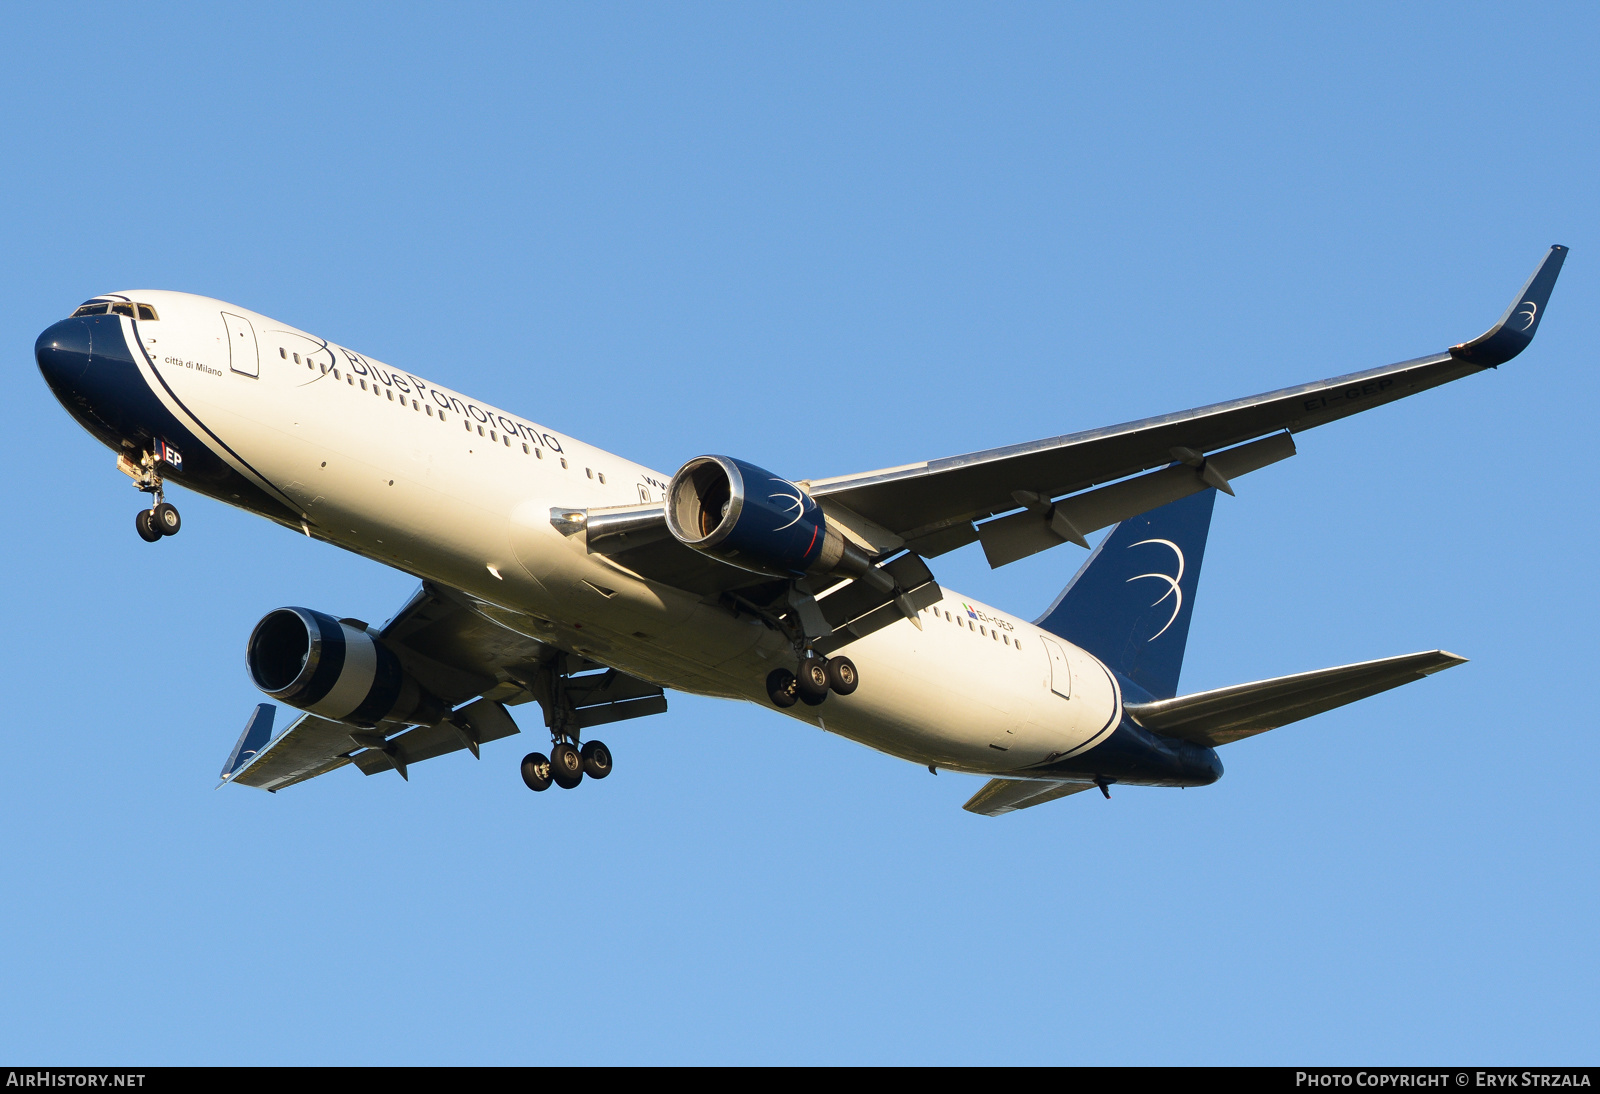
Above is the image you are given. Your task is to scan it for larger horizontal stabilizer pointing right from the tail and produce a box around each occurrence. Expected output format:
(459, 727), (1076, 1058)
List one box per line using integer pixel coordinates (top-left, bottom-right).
(1126, 649), (1467, 749)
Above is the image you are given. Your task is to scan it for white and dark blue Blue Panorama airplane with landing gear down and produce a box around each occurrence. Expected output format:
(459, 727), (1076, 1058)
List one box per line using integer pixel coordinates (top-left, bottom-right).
(34, 246), (1566, 816)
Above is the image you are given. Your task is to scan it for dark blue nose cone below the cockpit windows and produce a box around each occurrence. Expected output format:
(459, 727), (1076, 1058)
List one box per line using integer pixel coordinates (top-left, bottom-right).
(34, 315), (157, 448)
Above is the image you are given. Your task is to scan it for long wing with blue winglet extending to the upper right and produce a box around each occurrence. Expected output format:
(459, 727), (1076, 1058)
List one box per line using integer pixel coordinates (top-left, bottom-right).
(806, 246), (1566, 565)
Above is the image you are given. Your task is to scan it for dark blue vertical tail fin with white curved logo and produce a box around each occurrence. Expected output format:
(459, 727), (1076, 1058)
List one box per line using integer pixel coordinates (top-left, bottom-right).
(1035, 489), (1216, 699)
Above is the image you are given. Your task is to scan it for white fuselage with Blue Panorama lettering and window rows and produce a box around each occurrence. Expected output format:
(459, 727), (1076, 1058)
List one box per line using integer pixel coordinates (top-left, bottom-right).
(112, 291), (1122, 774)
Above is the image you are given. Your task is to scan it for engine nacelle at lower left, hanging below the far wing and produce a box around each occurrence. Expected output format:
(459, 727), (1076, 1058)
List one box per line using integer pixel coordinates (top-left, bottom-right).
(245, 608), (445, 728)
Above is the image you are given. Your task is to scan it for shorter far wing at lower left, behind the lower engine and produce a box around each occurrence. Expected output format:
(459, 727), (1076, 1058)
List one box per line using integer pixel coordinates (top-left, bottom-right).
(222, 582), (667, 792)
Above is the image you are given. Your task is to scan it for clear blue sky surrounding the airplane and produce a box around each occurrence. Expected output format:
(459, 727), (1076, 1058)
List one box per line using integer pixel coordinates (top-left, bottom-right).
(0, 3), (1600, 1064)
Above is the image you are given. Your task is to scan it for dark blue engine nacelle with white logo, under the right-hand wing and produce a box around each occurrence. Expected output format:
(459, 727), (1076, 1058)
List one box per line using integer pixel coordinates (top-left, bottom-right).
(667, 456), (870, 577)
